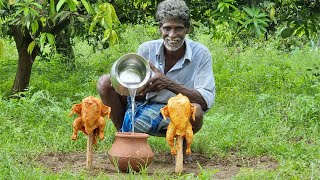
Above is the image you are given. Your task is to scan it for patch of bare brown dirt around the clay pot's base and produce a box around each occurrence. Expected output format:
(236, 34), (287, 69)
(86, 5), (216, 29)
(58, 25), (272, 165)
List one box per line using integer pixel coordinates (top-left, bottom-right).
(37, 152), (278, 180)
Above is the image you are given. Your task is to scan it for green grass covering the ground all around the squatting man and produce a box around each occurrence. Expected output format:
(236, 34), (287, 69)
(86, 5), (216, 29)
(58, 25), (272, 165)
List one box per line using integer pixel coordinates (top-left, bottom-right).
(0, 23), (320, 179)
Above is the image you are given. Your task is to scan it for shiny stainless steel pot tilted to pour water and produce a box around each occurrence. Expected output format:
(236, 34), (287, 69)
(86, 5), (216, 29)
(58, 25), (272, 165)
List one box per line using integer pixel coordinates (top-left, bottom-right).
(110, 53), (151, 96)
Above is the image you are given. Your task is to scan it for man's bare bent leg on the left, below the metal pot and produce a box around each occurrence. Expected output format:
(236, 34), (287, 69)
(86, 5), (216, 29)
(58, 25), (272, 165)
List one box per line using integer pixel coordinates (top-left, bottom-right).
(97, 74), (127, 131)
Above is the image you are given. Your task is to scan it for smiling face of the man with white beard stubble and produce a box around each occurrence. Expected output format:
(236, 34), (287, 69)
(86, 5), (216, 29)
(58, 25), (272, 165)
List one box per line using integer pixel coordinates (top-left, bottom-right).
(160, 20), (188, 51)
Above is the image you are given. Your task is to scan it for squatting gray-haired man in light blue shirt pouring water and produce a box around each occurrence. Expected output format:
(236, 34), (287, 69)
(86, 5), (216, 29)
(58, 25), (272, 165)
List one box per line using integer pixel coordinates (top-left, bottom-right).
(97, 0), (215, 161)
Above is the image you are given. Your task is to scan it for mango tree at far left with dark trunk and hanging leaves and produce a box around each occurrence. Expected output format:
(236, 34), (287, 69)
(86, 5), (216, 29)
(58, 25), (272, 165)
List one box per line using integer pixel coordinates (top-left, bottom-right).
(0, 0), (119, 94)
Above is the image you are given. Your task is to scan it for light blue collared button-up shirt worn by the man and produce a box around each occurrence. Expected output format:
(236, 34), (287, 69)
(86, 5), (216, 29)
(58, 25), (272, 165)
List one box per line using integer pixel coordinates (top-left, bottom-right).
(137, 38), (215, 109)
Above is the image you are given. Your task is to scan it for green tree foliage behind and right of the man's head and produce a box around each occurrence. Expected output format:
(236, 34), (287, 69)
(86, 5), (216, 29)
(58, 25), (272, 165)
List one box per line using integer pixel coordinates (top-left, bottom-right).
(112, 0), (320, 42)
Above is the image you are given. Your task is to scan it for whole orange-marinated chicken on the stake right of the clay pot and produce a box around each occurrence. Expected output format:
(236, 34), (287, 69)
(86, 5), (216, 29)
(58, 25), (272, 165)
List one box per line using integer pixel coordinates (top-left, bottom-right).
(160, 93), (196, 155)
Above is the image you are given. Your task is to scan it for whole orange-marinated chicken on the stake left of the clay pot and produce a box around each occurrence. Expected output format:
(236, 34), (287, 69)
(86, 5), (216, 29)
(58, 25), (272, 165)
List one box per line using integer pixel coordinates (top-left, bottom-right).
(69, 96), (111, 144)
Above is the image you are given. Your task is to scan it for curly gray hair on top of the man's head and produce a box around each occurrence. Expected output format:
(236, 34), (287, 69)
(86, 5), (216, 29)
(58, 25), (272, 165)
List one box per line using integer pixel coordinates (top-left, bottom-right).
(156, 0), (190, 28)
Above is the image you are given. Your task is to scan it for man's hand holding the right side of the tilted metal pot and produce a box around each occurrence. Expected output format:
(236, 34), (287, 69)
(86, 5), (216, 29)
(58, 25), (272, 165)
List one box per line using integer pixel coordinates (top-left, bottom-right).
(139, 62), (173, 95)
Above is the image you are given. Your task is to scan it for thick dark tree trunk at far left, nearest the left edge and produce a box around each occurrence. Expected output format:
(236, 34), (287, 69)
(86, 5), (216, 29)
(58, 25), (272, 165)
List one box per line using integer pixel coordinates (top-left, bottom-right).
(11, 26), (39, 94)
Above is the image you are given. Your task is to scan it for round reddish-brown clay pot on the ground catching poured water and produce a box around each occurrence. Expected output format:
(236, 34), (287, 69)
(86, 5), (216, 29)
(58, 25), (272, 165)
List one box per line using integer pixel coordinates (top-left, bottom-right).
(108, 132), (154, 172)
